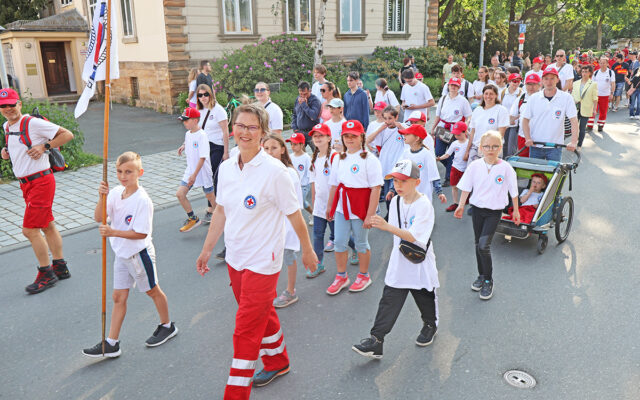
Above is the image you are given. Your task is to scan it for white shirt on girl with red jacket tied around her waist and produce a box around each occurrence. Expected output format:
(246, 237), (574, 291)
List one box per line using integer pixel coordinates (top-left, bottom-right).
(329, 151), (384, 219)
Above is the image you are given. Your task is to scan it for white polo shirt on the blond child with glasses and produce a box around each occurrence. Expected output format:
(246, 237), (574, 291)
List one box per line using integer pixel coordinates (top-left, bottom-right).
(458, 158), (518, 210)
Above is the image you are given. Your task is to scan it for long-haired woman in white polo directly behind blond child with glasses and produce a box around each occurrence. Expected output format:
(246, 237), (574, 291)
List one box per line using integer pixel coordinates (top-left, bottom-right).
(463, 85), (509, 161)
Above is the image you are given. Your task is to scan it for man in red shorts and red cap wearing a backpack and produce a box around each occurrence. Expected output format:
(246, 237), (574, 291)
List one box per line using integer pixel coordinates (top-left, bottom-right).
(0, 89), (73, 294)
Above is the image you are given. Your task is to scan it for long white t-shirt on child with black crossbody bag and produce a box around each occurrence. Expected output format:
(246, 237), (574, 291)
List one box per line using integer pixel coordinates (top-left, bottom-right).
(384, 196), (440, 291)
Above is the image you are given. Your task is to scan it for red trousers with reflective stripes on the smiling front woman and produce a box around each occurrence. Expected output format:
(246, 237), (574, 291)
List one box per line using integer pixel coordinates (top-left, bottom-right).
(224, 265), (289, 400)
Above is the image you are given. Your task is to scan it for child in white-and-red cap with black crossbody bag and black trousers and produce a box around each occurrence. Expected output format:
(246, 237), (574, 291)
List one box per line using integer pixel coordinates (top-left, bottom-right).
(352, 160), (440, 359)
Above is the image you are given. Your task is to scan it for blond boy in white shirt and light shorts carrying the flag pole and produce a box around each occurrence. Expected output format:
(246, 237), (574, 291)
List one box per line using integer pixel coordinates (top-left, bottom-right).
(82, 152), (178, 358)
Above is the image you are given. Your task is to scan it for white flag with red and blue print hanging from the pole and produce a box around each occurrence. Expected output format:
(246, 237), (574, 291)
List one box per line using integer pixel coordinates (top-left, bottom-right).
(74, 0), (120, 118)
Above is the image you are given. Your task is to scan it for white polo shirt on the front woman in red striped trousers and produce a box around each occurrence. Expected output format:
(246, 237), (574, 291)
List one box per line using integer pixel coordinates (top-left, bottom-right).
(216, 149), (300, 275)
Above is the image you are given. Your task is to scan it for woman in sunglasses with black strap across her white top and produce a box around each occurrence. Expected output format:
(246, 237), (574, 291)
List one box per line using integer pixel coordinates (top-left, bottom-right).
(197, 83), (229, 224)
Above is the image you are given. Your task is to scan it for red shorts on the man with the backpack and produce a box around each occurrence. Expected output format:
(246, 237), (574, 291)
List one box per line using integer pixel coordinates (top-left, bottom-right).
(20, 174), (56, 229)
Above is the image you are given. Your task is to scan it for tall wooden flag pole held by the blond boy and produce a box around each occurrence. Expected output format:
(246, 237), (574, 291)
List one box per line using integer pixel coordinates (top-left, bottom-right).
(100, 0), (111, 357)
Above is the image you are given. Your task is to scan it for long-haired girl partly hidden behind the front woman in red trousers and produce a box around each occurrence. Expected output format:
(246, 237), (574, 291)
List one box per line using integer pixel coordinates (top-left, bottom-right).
(262, 134), (304, 308)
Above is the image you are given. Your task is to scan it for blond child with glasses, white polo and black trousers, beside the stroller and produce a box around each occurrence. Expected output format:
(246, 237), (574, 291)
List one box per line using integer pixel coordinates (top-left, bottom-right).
(453, 130), (520, 300)
